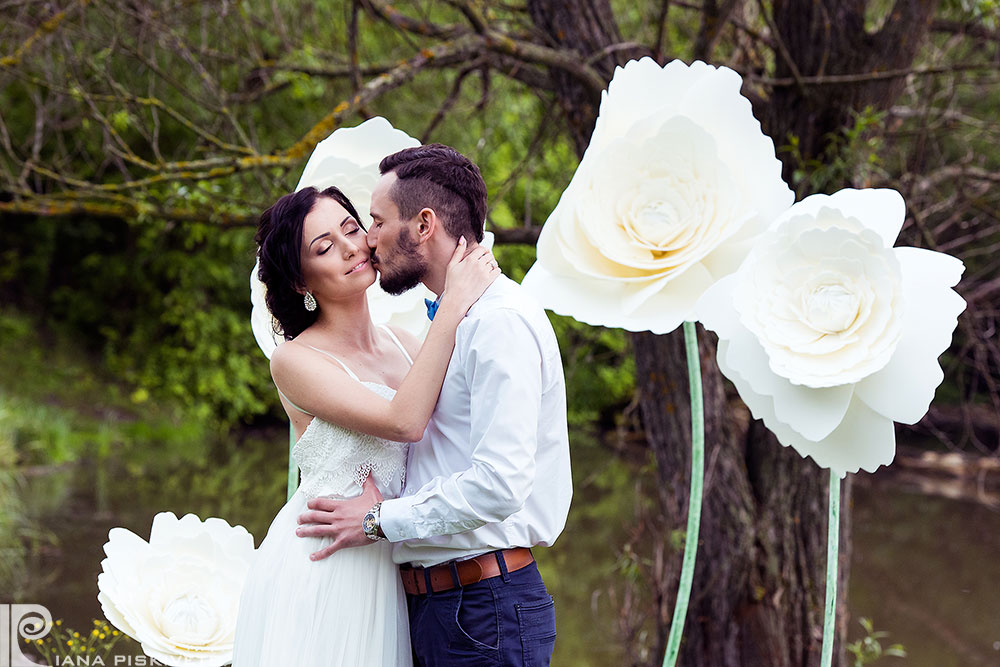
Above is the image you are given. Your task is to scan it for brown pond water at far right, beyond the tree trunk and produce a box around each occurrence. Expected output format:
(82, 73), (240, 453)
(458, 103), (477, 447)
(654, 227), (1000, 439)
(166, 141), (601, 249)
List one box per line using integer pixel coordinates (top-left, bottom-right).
(849, 471), (1000, 667)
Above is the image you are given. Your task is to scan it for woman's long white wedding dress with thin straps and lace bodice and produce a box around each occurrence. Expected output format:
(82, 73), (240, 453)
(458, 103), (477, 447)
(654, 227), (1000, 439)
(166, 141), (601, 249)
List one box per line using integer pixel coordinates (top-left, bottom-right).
(233, 329), (413, 667)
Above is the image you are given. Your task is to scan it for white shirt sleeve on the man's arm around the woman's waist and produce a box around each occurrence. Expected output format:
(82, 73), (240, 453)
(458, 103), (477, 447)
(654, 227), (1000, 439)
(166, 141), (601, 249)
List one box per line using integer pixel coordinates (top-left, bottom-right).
(380, 308), (542, 542)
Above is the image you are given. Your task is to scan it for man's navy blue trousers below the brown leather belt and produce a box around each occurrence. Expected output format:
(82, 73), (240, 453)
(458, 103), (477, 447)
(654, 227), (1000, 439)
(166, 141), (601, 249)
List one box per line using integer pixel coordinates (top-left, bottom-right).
(406, 563), (556, 667)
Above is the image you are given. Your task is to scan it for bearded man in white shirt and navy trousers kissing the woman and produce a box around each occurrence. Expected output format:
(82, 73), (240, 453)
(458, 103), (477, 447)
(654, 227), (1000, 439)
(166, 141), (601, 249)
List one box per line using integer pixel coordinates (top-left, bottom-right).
(299, 144), (572, 665)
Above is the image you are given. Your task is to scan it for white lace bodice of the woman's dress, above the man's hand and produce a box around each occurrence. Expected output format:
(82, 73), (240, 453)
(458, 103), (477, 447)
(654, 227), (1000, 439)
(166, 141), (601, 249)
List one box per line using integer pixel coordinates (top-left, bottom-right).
(292, 382), (409, 498)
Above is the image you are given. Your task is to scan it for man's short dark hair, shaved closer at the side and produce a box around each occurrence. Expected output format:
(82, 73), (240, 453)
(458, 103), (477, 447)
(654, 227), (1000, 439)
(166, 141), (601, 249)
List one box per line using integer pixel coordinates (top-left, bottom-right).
(378, 144), (486, 243)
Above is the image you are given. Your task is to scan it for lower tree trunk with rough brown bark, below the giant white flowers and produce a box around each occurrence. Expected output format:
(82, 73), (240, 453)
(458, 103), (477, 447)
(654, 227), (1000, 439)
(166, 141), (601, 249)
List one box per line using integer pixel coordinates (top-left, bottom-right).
(632, 328), (850, 667)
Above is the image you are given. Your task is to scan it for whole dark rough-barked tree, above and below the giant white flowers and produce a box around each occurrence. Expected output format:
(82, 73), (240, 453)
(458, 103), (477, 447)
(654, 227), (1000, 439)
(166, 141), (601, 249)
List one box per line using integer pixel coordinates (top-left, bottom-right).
(528, 0), (936, 667)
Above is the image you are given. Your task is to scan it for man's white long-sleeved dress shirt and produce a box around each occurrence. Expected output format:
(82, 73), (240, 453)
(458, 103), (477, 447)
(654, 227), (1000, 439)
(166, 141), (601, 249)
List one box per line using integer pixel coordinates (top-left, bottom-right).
(380, 275), (573, 567)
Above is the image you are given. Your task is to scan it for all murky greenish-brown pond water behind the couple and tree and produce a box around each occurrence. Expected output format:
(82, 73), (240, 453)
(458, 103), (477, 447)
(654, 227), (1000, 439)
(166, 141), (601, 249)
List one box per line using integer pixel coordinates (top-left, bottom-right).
(7, 434), (1000, 667)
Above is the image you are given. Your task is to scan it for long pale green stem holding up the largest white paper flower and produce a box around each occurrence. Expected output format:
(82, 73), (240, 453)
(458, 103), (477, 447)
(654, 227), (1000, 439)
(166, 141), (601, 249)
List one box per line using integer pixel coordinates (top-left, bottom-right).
(663, 322), (705, 667)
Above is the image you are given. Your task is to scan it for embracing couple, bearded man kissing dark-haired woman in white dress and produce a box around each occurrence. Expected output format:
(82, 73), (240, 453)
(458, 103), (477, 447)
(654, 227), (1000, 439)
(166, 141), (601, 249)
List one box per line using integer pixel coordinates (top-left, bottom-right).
(233, 144), (572, 667)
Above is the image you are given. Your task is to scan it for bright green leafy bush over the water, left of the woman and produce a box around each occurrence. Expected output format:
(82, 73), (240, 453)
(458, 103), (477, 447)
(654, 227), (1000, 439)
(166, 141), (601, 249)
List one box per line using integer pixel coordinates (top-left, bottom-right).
(101, 225), (272, 424)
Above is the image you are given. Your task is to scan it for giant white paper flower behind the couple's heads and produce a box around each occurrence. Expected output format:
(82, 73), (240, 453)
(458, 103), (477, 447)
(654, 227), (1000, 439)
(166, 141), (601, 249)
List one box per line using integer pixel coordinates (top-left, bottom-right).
(250, 117), (434, 359)
